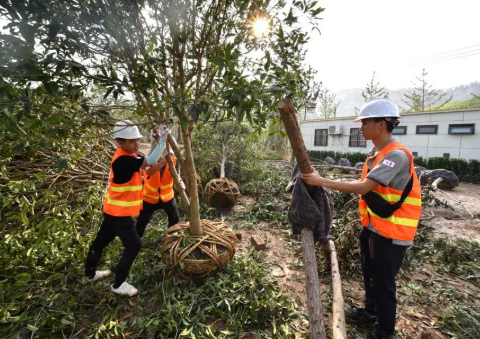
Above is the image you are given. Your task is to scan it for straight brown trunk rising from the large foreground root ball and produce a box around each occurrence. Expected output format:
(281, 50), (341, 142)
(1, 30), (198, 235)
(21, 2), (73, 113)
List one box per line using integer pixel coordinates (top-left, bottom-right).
(182, 122), (203, 236)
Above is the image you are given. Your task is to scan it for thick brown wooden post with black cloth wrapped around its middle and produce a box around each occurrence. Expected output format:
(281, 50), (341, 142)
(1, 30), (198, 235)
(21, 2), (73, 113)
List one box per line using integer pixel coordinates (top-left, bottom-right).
(278, 99), (327, 339)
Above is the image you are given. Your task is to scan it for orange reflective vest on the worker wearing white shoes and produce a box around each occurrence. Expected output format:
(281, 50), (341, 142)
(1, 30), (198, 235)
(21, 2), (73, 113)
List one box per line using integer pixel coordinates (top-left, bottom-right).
(103, 148), (143, 217)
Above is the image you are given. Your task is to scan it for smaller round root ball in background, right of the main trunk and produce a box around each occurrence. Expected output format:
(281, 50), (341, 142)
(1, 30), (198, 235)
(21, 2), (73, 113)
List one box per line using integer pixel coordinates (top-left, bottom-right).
(204, 178), (240, 210)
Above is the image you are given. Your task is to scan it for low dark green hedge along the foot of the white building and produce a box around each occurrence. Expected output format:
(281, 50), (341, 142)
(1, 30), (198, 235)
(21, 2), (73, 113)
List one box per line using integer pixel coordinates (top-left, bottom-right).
(308, 151), (480, 184)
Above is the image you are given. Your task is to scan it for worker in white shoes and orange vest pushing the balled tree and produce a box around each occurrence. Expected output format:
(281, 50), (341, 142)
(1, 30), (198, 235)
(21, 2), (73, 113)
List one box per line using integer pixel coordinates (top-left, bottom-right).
(85, 120), (169, 297)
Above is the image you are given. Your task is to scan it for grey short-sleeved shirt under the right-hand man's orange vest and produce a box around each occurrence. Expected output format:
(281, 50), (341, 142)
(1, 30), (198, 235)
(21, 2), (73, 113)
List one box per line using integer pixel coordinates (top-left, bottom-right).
(367, 138), (413, 246)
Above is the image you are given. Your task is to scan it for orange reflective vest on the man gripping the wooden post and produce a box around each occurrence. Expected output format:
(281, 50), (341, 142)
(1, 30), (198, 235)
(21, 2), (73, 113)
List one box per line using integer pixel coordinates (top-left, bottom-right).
(358, 141), (422, 241)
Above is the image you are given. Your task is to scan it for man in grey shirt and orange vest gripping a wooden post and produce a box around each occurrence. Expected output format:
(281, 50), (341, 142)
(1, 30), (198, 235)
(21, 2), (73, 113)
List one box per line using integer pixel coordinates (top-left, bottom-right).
(302, 98), (421, 339)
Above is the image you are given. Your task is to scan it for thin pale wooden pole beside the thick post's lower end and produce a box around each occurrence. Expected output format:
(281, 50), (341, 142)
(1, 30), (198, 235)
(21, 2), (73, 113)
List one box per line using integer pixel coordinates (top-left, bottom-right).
(329, 240), (348, 339)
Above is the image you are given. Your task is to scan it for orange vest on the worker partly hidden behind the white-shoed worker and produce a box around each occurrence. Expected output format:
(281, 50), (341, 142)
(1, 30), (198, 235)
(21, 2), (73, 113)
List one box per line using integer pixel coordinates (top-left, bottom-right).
(143, 155), (177, 204)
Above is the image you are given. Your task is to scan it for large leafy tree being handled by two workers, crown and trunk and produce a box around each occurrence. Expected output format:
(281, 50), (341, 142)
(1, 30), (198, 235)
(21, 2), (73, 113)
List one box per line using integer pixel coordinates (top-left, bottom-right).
(0, 0), (323, 235)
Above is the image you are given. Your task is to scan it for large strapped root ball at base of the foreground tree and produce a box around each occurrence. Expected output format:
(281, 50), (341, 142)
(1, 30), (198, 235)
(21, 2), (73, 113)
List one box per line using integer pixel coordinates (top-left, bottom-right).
(160, 220), (238, 277)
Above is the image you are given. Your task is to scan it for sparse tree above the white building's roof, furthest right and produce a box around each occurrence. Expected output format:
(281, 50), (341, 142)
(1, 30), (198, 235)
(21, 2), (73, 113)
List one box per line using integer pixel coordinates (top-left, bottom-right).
(402, 68), (453, 112)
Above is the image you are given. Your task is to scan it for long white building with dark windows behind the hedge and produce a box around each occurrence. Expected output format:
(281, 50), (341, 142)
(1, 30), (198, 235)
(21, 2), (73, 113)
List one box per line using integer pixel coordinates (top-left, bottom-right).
(300, 108), (480, 160)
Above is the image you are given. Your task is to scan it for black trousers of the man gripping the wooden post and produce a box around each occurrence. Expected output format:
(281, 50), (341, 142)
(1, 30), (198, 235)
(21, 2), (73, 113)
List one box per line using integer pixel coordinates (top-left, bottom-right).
(360, 227), (407, 338)
